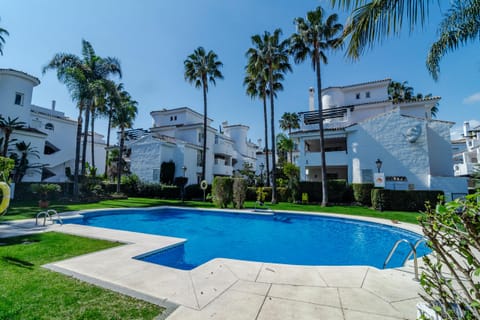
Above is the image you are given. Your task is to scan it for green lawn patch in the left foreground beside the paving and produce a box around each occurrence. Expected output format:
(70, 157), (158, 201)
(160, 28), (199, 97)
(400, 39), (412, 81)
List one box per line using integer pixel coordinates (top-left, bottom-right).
(0, 232), (163, 320)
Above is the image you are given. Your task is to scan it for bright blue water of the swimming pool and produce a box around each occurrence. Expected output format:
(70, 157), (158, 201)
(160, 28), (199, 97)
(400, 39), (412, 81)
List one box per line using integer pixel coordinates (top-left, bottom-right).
(65, 208), (428, 270)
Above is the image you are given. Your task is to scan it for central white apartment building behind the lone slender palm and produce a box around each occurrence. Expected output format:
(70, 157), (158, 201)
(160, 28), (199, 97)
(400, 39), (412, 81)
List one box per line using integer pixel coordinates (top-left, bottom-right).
(127, 107), (258, 184)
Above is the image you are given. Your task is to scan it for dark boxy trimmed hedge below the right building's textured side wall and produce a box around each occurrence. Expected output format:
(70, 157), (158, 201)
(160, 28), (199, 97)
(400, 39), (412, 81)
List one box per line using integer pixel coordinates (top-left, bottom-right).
(371, 189), (443, 211)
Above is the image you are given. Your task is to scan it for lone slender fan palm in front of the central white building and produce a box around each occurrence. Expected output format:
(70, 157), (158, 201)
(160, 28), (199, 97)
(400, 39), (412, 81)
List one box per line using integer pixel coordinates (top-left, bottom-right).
(184, 47), (223, 180)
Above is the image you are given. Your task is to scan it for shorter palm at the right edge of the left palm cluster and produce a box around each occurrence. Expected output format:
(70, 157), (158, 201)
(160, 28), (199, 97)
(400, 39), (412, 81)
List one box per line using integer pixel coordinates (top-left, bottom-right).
(112, 91), (138, 193)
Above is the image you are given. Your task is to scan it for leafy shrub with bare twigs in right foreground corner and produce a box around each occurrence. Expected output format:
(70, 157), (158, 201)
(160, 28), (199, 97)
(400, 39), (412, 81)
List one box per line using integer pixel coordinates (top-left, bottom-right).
(419, 193), (480, 319)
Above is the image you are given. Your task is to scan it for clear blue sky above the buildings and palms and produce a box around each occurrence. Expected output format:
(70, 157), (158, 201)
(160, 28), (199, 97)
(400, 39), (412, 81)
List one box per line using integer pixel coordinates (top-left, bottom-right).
(0, 0), (480, 141)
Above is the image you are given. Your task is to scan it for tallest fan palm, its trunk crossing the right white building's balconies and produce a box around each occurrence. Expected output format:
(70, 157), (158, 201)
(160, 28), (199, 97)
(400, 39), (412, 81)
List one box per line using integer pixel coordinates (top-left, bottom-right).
(291, 7), (343, 206)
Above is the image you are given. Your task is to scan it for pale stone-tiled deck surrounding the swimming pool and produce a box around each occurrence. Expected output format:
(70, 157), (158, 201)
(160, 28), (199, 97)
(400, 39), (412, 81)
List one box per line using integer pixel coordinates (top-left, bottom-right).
(0, 210), (421, 320)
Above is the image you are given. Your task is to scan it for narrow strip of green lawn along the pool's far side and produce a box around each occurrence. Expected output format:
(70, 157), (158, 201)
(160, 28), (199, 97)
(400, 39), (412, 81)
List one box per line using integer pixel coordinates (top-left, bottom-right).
(0, 198), (420, 223)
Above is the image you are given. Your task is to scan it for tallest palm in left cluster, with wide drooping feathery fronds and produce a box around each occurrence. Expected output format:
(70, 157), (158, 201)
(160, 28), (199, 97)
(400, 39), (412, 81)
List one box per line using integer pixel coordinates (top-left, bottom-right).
(43, 40), (121, 196)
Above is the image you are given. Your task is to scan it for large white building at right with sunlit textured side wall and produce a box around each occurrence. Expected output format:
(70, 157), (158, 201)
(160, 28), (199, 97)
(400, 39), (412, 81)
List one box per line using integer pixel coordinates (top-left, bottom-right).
(292, 79), (467, 198)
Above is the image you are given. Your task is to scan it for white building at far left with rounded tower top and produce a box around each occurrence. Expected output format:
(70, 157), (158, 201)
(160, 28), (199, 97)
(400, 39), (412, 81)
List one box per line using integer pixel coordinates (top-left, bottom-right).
(0, 69), (105, 182)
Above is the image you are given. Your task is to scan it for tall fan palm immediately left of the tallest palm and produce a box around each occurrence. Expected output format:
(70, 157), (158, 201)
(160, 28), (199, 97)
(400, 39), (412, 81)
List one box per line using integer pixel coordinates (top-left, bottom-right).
(247, 29), (292, 203)
